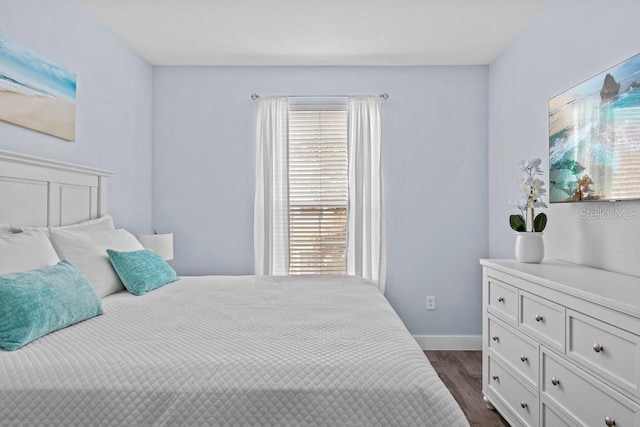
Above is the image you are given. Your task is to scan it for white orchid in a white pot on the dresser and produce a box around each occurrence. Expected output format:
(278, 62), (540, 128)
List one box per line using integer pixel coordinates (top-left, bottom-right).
(509, 159), (547, 263)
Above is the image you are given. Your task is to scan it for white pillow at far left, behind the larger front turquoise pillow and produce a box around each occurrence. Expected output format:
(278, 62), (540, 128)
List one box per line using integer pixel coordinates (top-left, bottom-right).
(0, 231), (60, 274)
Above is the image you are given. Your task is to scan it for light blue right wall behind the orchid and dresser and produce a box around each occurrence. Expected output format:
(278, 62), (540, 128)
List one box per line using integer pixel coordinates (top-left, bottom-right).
(489, 0), (640, 275)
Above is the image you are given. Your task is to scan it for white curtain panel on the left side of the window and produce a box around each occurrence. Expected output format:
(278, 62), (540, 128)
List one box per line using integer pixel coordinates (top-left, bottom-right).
(254, 96), (289, 276)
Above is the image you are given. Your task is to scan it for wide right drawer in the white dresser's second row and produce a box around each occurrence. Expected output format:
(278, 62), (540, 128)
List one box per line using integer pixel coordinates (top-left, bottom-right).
(541, 350), (640, 427)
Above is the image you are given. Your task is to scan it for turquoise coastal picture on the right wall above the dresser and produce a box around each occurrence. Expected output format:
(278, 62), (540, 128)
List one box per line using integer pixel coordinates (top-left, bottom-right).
(549, 54), (640, 202)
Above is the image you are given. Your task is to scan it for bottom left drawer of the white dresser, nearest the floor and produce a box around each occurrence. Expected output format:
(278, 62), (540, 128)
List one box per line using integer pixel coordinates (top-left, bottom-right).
(488, 356), (539, 426)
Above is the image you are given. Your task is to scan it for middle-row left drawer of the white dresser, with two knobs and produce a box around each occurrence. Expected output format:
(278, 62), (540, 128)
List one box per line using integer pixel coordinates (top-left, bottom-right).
(488, 317), (539, 389)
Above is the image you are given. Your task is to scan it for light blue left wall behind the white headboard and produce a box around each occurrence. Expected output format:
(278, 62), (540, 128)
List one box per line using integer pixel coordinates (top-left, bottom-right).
(0, 0), (152, 232)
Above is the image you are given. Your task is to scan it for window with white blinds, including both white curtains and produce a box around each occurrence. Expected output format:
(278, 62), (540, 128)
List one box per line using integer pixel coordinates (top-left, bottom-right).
(254, 95), (386, 292)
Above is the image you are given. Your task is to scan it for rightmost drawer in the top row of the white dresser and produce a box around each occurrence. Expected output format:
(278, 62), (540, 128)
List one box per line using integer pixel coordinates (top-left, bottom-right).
(567, 310), (640, 396)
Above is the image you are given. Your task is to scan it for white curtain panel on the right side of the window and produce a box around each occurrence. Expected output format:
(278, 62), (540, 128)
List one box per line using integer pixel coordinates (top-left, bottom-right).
(347, 96), (386, 292)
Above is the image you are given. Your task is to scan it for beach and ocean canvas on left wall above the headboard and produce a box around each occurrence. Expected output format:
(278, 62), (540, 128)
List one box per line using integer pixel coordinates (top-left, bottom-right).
(0, 33), (76, 141)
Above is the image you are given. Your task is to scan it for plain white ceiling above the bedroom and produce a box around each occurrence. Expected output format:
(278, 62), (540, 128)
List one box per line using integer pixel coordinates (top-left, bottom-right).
(77, 0), (552, 65)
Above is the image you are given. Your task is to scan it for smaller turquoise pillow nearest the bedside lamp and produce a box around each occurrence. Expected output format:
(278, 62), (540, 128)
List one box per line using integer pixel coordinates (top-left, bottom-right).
(107, 249), (178, 295)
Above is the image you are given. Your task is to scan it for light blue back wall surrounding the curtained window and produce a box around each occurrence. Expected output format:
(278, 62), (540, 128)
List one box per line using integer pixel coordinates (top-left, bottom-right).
(153, 67), (488, 335)
